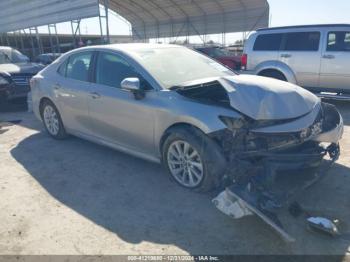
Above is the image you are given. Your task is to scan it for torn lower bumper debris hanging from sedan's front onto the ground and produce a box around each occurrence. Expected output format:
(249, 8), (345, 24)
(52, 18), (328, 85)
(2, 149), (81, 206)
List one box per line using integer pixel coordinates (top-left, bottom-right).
(213, 142), (340, 242)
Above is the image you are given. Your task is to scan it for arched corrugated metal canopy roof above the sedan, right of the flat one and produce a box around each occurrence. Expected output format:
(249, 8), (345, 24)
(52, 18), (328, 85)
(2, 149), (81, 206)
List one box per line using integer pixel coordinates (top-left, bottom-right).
(105, 0), (269, 39)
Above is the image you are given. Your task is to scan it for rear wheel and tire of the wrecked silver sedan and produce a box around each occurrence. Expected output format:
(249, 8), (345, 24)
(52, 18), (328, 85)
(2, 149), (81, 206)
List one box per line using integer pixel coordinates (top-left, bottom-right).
(40, 100), (68, 140)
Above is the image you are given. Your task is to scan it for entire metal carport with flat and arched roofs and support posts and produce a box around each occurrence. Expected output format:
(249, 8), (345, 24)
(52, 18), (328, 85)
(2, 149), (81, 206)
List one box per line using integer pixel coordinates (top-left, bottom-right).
(0, 0), (269, 55)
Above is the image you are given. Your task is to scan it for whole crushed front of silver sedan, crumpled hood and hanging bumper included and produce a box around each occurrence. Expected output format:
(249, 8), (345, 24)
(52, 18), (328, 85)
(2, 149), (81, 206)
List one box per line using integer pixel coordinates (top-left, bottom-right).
(176, 76), (343, 241)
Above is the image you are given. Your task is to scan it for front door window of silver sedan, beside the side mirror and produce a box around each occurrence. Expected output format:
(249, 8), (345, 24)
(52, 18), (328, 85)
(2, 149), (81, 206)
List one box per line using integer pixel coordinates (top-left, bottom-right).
(96, 52), (141, 88)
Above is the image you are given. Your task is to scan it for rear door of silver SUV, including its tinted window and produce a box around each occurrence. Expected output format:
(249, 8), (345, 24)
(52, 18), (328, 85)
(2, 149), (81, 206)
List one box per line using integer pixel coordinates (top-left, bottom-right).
(279, 31), (321, 88)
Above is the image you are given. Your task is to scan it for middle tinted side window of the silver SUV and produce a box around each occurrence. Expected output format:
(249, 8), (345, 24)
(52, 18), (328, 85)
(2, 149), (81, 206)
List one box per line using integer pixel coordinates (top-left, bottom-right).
(283, 32), (321, 51)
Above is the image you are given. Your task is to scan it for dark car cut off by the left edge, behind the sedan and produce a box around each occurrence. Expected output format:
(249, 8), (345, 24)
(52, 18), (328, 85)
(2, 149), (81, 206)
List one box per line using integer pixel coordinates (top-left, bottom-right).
(0, 46), (43, 101)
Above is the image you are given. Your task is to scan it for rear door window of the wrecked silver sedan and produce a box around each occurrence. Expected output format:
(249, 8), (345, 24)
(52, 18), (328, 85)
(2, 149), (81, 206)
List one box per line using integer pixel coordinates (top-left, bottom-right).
(66, 52), (92, 82)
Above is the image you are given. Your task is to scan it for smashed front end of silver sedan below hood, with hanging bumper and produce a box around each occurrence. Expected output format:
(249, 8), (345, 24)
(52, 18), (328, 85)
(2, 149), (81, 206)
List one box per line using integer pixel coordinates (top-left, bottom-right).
(211, 103), (343, 241)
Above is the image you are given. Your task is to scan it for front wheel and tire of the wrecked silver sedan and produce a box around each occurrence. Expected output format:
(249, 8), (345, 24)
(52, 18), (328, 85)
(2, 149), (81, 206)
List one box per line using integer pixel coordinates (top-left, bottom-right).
(162, 127), (226, 192)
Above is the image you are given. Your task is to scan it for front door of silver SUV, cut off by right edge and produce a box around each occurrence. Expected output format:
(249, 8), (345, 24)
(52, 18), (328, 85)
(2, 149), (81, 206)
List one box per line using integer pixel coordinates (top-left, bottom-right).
(320, 30), (350, 92)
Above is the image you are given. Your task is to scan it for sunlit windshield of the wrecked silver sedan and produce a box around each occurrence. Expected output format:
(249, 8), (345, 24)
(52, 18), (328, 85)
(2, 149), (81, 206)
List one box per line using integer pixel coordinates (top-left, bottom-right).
(129, 47), (235, 88)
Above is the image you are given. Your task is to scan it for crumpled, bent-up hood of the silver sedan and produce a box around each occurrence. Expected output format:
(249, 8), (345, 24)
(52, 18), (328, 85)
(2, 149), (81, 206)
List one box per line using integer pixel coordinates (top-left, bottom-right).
(218, 75), (320, 120)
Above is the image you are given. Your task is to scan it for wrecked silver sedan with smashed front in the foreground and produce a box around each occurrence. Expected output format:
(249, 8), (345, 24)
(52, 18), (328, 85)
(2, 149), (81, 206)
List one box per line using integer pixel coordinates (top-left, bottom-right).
(31, 44), (343, 194)
